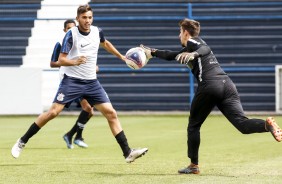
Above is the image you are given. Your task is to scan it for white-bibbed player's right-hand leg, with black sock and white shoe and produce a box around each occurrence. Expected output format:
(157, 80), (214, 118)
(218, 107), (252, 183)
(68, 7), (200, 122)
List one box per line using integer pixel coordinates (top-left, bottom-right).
(95, 102), (148, 163)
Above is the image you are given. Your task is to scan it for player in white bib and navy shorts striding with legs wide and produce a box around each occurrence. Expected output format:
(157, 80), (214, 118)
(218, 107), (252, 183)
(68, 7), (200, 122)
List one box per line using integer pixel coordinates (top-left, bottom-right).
(11, 4), (148, 163)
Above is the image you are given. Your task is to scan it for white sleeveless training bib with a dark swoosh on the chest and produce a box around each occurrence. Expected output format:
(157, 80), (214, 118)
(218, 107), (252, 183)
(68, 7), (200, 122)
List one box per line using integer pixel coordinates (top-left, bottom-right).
(61, 26), (100, 80)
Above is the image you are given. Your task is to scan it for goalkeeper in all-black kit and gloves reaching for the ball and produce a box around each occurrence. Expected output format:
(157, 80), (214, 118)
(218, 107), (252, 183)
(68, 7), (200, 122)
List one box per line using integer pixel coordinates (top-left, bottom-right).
(140, 19), (282, 174)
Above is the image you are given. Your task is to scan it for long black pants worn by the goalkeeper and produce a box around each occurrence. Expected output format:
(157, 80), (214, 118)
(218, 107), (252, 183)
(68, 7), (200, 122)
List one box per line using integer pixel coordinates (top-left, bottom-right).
(187, 77), (267, 164)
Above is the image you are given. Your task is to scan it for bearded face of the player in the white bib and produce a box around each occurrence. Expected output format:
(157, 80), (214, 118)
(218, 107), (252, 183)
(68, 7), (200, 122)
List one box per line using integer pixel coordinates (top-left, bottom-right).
(76, 11), (93, 32)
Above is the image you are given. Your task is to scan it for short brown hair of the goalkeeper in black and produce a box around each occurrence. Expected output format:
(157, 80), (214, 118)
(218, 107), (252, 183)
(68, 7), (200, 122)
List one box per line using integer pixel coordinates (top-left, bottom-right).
(179, 18), (200, 37)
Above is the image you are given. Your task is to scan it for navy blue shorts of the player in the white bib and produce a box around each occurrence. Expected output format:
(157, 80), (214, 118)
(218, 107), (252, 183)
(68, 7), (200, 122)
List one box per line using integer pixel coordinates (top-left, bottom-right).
(53, 75), (111, 106)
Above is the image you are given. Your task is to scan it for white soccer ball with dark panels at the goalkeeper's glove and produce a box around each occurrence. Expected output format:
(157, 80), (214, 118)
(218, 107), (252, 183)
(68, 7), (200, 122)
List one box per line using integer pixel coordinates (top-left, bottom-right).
(125, 47), (148, 70)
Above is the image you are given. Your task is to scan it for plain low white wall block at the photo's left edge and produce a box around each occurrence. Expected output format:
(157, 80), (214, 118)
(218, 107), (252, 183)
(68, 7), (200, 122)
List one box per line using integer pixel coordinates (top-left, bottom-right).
(0, 67), (43, 115)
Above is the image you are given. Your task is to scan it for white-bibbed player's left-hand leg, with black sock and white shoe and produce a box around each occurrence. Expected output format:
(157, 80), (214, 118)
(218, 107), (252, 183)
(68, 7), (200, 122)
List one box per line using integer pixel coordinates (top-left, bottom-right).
(11, 103), (64, 158)
